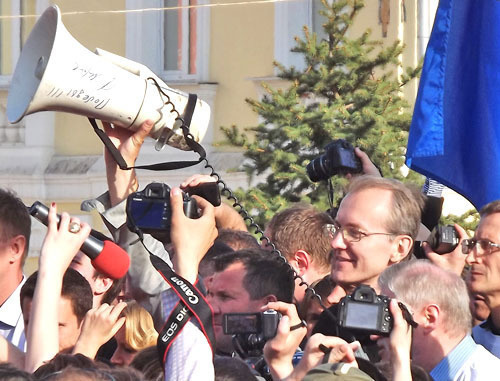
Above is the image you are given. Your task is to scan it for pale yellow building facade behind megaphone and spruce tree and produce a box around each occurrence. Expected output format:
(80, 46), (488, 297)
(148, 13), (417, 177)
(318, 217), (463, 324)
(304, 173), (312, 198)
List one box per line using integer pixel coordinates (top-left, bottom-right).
(0, 0), (437, 273)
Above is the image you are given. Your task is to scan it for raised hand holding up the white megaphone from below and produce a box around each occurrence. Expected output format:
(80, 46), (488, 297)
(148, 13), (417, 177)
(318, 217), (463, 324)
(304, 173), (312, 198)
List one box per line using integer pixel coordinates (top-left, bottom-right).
(103, 120), (153, 206)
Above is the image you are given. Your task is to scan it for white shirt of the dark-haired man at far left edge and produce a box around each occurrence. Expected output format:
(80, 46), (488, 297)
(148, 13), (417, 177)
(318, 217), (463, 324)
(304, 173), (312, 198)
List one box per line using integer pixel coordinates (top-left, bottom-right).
(0, 276), (26, 352)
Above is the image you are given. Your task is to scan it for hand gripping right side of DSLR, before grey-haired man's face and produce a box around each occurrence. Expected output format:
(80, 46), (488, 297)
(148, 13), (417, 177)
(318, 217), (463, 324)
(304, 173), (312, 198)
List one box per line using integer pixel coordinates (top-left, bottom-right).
(371, 299), (412, 381)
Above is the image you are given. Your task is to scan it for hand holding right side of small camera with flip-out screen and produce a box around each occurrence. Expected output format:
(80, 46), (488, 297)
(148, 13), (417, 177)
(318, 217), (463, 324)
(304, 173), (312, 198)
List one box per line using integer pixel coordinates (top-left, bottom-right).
(261, 302), (307, 380)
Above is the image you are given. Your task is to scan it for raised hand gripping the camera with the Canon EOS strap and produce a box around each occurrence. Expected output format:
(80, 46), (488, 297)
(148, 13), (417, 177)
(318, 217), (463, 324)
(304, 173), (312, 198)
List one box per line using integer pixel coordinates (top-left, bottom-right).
(170, 188), (217, 284)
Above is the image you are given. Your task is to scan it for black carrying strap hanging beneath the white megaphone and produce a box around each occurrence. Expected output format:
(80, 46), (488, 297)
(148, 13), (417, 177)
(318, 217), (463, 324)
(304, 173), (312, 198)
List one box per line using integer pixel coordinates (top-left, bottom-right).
(88, 94), (207, 171)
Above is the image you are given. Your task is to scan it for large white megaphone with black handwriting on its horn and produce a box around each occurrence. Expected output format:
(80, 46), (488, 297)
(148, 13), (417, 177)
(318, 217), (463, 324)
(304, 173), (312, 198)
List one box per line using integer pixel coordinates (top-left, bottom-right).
(7, 6), (210, 150)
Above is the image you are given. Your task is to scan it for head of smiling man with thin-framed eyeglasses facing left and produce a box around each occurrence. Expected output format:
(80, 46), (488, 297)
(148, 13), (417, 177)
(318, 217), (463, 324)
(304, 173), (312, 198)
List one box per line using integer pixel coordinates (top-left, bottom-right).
(326, 176), (421, 296)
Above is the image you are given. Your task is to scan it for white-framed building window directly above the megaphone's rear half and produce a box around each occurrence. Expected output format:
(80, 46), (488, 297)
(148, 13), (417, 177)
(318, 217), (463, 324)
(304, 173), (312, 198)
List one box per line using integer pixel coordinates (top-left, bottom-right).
(127, 0), (210, 82)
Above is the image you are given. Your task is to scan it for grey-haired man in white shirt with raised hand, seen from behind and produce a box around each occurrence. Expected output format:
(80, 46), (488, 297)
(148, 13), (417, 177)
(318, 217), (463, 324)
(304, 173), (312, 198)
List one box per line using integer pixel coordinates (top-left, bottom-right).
(378, 260), (500, 381)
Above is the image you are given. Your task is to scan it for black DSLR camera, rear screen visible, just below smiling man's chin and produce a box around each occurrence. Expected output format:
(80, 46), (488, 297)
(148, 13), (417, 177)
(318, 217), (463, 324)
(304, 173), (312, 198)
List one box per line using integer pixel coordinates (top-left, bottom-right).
(337, 284), (393, 336)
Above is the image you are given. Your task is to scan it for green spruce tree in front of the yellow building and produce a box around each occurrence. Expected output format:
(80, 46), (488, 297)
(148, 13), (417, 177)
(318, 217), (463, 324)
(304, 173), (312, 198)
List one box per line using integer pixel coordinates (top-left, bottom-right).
(222, 0), (420, 224)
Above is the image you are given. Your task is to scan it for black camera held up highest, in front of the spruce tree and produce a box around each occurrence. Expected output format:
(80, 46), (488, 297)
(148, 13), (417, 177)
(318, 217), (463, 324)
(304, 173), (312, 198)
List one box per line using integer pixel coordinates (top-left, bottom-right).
(306, 139), (363, 182)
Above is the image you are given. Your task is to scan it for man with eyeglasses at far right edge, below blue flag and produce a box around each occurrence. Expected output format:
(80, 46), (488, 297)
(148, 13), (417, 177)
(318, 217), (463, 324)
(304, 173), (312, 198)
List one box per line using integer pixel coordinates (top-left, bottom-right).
(462, 200), (500, 357)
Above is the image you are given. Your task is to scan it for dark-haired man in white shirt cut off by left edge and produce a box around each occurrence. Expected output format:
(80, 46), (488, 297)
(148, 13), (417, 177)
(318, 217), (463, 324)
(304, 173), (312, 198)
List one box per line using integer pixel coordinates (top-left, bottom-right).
(0, 189), (31, 351)
